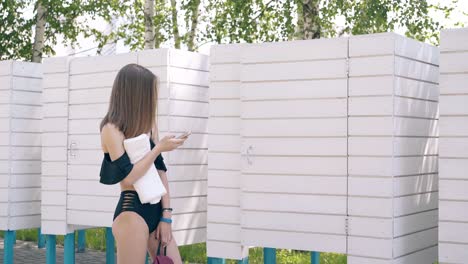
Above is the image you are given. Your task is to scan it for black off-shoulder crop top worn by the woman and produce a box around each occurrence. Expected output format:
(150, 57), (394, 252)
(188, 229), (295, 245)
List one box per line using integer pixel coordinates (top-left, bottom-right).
(99, 138), (167, 185)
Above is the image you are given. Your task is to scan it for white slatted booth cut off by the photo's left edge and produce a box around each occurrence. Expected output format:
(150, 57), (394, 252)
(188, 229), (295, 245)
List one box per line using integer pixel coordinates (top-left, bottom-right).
(0, 60), (42, 230)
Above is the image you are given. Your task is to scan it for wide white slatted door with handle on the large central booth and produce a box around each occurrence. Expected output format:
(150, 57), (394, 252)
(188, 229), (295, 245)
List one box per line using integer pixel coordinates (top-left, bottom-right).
(240, 38), (348, 253)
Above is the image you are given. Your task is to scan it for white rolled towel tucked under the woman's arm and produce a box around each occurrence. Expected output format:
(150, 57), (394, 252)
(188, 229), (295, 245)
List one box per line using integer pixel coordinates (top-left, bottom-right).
(124, 134), (167, 204)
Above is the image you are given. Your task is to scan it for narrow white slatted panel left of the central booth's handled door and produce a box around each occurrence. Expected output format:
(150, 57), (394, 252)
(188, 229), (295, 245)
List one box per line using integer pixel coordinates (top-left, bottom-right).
(206, 44), (248, 259)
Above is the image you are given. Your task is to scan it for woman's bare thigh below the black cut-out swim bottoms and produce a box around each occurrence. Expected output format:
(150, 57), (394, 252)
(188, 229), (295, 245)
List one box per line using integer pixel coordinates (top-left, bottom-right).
(112, 211), (148, 264)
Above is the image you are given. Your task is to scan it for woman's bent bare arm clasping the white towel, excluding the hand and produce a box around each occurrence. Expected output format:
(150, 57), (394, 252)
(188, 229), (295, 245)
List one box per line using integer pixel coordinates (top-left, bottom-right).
(102, 124), (161, 185)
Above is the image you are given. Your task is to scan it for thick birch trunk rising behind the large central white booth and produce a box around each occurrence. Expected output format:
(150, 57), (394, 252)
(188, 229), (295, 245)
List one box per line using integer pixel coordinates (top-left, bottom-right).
(298, 0), (321, 39)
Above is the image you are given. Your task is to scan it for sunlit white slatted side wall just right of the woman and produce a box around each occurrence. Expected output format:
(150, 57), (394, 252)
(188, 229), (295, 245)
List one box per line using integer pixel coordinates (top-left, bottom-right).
(150, 49), (209, 245)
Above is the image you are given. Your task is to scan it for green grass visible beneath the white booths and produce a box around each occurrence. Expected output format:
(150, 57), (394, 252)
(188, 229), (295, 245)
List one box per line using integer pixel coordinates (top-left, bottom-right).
(0, 228), (346, 264)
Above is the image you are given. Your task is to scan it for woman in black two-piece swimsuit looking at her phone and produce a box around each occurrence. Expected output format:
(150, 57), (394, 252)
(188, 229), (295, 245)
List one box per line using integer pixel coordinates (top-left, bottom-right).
(100, 64), (187, 264)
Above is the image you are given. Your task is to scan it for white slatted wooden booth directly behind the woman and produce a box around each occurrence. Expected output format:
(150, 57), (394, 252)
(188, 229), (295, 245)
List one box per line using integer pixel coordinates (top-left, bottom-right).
(42, 49), (208, 245)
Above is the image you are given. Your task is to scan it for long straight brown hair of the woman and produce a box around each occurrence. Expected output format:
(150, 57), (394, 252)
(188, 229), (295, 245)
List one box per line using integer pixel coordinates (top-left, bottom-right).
(99, 63), (158, 138)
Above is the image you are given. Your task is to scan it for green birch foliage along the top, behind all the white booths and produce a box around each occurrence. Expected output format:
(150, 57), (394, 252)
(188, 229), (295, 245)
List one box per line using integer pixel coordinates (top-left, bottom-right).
(0, 0), (462, 60)
